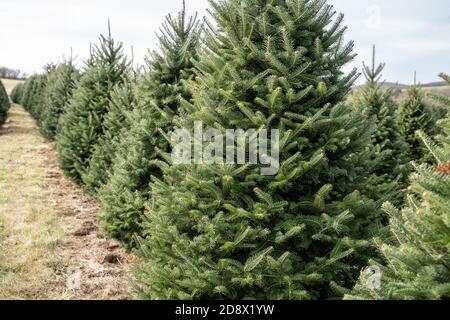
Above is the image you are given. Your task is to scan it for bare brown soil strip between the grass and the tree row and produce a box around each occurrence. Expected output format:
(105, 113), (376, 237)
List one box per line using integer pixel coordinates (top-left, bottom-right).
(39, 144), (133, 299)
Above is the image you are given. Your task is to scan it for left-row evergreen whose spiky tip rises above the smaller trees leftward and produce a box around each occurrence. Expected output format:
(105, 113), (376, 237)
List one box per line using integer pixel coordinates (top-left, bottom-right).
(57, 25), (129, 183)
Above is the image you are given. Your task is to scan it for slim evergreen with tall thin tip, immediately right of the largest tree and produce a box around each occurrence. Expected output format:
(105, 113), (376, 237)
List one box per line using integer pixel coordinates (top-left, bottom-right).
(354, 46), (410, 205)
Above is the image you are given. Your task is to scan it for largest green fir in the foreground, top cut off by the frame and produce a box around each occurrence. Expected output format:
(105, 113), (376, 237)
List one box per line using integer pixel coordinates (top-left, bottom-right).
(135, 0), (384, 299)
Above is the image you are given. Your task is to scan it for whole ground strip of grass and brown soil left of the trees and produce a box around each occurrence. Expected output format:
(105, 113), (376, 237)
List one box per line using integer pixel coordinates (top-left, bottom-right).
(0, 105), (133, 299)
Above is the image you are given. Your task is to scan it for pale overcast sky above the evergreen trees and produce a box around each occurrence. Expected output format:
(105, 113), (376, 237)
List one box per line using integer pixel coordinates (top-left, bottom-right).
(0, 0), (450, 83)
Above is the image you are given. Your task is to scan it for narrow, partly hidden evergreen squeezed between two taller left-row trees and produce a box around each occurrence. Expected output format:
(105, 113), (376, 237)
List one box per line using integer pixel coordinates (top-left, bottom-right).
(82, 75), (136, 195)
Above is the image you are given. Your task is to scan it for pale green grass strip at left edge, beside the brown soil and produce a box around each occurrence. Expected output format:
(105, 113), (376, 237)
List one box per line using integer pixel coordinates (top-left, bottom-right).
(0, 104), (62, 299)
